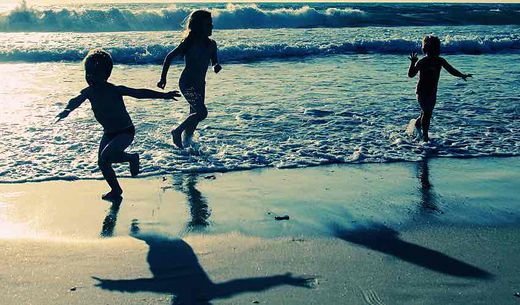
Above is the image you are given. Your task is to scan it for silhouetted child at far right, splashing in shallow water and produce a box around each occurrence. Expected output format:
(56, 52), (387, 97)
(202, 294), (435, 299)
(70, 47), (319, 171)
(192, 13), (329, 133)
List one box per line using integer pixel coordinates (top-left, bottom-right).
(408, 35), (472, 142)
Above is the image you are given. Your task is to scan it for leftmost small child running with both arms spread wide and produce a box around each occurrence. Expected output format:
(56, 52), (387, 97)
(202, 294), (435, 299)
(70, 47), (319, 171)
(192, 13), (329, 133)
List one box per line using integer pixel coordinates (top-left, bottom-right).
(56, 49), (180, 201)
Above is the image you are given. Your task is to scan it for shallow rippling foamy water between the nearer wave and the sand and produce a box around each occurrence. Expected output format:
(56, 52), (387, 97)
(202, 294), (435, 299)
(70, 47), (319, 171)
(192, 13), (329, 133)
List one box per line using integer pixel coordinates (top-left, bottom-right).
(0, 54), (520, 181)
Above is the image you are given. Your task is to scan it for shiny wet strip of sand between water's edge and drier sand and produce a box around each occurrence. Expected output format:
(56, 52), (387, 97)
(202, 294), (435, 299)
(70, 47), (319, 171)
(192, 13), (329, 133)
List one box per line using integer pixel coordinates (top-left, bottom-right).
(0, 154), (520, 237)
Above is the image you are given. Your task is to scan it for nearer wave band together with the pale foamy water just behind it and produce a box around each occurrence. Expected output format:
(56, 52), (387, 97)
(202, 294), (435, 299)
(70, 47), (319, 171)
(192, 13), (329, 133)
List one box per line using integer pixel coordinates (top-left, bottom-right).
(0, 26), (520, 64)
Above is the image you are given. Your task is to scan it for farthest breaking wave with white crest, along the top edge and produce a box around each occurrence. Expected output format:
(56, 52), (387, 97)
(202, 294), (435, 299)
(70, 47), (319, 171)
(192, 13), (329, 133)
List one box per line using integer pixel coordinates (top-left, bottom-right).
(0, 4), (520, 32)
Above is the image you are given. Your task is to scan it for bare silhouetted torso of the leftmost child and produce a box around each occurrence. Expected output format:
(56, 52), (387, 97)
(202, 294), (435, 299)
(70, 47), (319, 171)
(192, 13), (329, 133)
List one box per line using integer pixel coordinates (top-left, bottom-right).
(81, 83), (133, 133)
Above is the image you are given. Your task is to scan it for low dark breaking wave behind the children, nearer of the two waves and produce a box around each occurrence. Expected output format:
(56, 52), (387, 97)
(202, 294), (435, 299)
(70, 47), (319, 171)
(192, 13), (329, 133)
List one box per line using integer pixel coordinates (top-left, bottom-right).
(0, 35), (520, 64)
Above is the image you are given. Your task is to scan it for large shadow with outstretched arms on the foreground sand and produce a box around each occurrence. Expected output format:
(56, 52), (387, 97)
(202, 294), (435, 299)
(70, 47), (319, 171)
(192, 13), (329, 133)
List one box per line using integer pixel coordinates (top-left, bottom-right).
(93, 224), (311, 305)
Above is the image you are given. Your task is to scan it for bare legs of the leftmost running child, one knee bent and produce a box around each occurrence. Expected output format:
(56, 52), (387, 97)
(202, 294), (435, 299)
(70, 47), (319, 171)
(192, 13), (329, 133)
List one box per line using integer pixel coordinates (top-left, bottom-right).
(98, 134), (139, 200)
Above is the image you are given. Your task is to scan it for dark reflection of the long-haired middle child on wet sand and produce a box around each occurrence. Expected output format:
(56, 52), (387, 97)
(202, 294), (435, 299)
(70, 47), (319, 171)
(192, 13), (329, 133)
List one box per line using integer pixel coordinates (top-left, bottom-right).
(173, 174), (211, 232)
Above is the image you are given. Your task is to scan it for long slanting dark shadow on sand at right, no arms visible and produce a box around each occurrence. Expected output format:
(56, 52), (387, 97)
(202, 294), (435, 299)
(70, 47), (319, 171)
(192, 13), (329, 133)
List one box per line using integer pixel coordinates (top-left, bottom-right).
(331, 222), (493, 279)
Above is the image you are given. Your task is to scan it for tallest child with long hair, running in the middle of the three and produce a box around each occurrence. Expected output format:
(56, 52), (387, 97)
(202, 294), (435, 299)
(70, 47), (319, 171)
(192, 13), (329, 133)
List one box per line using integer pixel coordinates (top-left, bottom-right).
(157, 10), (222, 149)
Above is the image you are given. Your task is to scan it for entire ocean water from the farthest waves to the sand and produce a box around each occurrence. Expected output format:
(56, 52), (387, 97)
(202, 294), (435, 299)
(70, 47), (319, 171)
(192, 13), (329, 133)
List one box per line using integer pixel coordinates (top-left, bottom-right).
(0, 3), (520, 182)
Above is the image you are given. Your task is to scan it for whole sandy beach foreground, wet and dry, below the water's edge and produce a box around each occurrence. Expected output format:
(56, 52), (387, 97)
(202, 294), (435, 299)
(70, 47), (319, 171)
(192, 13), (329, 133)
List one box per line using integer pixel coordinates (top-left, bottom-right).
(0, 158), (520, 304)
